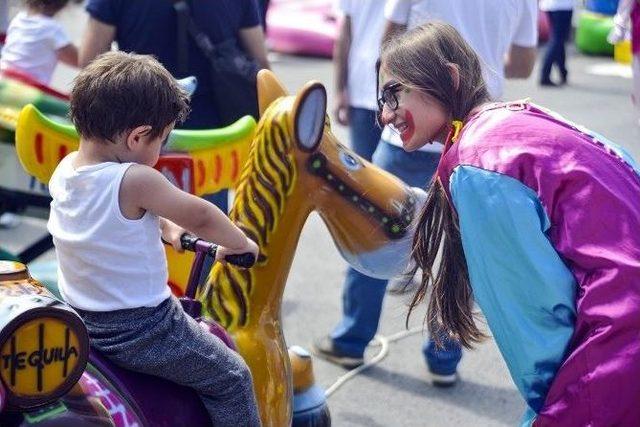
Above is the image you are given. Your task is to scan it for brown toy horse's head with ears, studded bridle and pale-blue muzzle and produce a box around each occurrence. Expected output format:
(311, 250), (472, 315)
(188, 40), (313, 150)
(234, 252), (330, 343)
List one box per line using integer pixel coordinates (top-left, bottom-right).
(258, 71), (425, 278)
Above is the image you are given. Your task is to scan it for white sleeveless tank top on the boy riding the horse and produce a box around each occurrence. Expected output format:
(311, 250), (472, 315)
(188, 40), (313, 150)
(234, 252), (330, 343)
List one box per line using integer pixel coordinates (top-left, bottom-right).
(47, 152), (170, 311)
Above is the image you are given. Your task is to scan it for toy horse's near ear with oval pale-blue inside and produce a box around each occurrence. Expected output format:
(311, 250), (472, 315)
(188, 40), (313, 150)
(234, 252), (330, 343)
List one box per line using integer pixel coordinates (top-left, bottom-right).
(293, 82), (327, 151)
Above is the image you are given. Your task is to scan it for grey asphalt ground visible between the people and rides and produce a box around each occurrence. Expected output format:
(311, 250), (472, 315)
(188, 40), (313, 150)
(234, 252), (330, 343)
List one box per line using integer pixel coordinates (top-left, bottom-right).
(0, 2), (640, 427)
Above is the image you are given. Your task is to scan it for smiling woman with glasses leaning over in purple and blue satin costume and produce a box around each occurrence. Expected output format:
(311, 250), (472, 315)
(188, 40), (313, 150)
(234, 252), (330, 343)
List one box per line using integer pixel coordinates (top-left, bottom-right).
(379, 21), (640, 426)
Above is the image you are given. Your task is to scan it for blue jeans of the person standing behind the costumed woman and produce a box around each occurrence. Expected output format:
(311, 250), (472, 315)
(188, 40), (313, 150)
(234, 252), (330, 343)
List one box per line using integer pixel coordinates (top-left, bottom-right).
(330, 141), (462, 375)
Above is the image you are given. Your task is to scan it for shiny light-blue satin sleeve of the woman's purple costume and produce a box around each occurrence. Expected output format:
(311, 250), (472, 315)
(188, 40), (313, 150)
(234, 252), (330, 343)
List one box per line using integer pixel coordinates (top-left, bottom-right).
(450, 166), (577, 425)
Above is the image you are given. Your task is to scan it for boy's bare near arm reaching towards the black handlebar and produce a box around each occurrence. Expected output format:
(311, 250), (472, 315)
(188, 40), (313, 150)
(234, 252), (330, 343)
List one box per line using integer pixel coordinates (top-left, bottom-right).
(120, 165), (248, 251)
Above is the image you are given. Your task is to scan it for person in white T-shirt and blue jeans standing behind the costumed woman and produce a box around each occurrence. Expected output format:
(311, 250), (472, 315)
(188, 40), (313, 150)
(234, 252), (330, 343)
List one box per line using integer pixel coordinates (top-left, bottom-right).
(314, 0), (538, 386)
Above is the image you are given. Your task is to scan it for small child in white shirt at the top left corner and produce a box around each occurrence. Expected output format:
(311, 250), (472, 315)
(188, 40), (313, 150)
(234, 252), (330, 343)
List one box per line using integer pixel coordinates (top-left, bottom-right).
(0, 0), (78, 85)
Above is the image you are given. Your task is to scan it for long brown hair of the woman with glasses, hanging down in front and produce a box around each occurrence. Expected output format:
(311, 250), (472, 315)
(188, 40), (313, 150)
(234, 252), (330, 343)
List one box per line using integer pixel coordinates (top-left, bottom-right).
(381, 21), (490, 347)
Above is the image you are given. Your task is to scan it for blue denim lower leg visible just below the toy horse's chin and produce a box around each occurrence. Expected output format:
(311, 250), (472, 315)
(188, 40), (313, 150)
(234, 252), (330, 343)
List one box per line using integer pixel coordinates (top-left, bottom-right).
(330, 268), (387, 357)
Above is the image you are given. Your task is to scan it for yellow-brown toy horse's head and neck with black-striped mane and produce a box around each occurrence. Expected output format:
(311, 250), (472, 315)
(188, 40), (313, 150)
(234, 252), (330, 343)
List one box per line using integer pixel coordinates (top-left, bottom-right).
(199, 70), (423, 426)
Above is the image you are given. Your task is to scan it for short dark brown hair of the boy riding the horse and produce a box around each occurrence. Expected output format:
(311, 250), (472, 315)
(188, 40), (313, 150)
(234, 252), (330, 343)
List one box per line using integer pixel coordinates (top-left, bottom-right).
(69, 52), (189, 142)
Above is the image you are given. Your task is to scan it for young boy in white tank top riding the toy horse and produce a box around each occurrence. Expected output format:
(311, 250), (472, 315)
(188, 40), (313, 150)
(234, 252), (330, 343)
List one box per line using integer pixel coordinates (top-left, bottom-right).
(48, 52), (260, 426)
